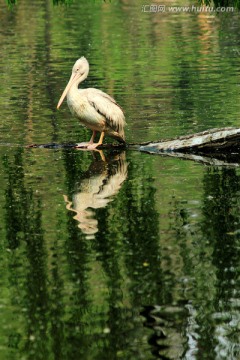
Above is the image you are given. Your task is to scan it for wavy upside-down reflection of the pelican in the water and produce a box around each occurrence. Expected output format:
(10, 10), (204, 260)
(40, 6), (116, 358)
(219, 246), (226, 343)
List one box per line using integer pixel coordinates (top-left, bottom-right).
(64, 151), (127, 235)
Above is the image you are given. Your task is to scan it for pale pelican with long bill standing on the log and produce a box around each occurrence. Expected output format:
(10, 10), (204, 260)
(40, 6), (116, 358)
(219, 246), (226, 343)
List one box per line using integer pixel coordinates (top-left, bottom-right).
(57, 56), (126, 150)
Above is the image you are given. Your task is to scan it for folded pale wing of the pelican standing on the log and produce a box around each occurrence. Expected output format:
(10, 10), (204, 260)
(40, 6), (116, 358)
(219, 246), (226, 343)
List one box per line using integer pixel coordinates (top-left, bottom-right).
(87, 88), (125, 135)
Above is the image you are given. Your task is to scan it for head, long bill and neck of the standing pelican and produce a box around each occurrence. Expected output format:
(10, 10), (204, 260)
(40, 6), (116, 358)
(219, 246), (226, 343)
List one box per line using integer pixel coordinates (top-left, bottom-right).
(57, 56), (89, 109)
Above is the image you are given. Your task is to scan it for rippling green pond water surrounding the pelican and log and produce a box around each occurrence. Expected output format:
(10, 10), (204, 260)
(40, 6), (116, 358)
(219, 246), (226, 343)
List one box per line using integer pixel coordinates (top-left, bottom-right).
(0, 0), (240, 360)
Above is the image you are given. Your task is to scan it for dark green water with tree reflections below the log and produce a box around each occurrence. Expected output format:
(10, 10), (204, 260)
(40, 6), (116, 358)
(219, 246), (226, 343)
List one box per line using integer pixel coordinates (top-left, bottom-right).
(1, 148), (240, 359)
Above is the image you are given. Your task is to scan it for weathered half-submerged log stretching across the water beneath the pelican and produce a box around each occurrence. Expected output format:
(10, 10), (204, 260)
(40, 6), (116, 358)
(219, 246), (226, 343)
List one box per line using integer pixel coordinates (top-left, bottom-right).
(28, 127), (240, 166)
